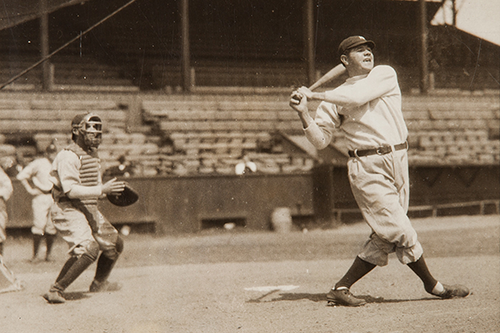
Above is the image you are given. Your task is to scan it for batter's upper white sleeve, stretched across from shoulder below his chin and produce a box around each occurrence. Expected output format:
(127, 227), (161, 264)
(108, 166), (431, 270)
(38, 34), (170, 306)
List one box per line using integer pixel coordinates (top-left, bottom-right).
(325, 66), (398, 109)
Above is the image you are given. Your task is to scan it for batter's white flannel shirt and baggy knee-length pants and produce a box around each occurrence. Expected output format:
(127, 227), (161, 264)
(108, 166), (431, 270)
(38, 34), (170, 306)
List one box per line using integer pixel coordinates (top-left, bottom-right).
(304, 66), (423, 266)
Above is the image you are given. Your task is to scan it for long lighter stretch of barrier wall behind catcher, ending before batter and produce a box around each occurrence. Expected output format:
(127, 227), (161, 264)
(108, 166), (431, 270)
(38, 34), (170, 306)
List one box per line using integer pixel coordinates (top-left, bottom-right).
(8, 174), (313, 234)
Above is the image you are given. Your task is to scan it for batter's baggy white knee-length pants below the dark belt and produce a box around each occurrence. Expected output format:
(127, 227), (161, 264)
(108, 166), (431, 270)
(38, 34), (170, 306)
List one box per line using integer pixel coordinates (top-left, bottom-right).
(348, 150), (423, 266)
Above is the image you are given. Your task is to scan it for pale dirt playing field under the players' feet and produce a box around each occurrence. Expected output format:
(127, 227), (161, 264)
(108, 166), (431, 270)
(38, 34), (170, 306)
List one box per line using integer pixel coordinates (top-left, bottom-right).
(0, 215), (500, 333)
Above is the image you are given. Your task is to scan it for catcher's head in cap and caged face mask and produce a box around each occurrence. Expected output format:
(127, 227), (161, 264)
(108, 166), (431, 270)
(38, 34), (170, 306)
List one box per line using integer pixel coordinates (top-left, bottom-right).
(71, 113), (102, 148)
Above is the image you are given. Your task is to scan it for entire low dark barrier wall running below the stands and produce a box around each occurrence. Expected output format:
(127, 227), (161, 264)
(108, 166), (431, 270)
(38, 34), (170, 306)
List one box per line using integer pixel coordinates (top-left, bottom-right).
(8, 165), (500, 234)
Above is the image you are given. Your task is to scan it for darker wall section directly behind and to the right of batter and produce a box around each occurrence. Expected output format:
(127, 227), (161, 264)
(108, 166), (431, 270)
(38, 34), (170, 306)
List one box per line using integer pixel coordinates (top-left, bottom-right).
(313, 164), (500, 219)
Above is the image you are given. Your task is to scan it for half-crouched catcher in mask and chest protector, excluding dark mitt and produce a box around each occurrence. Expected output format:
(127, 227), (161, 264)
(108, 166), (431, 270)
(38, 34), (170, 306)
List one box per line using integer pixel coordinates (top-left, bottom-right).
(43, 113), (125, 303)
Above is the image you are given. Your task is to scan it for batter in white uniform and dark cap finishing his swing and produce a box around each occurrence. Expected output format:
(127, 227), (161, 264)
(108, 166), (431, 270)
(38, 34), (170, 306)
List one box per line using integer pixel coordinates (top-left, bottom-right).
(290, 36), (469, 306)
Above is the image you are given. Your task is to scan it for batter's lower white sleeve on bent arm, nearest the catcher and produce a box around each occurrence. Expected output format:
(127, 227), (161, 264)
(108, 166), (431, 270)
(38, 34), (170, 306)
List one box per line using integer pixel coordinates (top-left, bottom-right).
(304, 102), (342, 150)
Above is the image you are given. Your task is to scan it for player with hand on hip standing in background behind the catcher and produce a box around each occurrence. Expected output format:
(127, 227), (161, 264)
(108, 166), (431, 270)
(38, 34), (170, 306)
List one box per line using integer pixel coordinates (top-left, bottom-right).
(17, 143), (57, 263)
